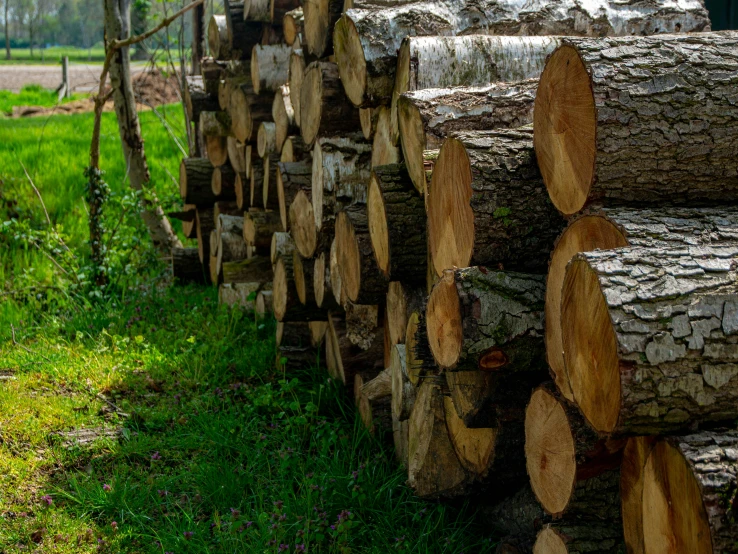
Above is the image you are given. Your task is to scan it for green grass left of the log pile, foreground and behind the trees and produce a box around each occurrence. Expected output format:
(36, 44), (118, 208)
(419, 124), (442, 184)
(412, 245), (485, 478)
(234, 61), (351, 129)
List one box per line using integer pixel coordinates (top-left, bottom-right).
(0, 98), (494, 554)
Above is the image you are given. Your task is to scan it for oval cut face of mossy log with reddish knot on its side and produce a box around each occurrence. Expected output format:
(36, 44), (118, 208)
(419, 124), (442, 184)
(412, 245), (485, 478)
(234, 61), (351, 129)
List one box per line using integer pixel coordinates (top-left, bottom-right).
(426, 270), (464, 369)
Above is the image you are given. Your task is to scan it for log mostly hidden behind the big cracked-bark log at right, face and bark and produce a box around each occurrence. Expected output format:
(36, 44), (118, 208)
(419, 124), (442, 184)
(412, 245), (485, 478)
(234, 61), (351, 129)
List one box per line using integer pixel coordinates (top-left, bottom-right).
(545, 208), (738, 401)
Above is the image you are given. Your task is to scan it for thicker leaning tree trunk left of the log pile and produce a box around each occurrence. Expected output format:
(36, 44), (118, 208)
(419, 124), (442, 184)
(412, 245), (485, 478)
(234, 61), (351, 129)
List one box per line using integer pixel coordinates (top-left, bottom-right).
(105, 0), (182, 255)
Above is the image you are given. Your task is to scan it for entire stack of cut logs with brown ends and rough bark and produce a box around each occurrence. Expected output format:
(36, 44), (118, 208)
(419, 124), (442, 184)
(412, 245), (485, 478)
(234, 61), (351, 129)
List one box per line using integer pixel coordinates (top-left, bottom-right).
(173, 0), (738, 554)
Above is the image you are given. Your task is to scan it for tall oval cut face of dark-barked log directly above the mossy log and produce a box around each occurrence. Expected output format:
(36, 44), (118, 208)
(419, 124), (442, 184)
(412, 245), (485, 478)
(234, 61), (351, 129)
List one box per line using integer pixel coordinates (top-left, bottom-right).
(428, 138), (474, 276)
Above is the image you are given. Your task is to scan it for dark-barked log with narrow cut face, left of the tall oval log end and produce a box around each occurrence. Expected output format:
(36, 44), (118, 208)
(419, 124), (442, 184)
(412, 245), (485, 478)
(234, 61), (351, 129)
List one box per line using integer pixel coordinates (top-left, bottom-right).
(367, 164), (428, 285)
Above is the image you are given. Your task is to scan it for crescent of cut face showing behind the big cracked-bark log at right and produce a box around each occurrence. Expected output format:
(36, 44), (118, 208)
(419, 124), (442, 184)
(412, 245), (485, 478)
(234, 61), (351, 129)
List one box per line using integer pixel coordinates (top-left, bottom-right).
(545, 215), (628, 401)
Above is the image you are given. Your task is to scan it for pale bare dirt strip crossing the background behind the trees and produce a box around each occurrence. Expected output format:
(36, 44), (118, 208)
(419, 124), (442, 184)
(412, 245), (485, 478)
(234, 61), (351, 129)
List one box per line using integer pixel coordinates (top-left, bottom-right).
(0, 64), (146, 92)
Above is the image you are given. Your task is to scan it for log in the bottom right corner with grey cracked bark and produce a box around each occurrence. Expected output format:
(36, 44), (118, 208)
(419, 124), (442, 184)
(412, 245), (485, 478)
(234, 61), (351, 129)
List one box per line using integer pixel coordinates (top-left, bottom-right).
(640, 430), (738, 554)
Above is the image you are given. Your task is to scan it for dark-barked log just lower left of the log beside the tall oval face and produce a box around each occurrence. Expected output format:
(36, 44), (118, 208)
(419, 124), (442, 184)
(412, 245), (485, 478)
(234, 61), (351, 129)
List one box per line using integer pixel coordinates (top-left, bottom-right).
(336, 204), (389, 304)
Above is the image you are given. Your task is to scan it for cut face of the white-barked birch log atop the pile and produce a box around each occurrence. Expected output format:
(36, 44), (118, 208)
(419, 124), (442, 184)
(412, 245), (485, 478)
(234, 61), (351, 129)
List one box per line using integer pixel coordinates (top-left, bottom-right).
(333, 15), (366, 107)
